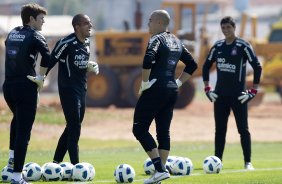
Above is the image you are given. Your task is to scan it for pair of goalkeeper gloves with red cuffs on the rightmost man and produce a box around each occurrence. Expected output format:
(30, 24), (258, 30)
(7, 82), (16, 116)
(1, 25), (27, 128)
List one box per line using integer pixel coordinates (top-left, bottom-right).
(205, 86), (258, 104)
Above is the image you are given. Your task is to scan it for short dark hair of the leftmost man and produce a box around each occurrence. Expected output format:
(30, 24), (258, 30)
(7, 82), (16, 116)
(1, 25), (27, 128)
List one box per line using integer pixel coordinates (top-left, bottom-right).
(21, 3), (47, 25)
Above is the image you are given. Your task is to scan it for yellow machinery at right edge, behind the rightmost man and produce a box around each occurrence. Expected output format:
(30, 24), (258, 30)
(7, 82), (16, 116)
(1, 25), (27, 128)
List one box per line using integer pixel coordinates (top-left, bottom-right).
(240, 14), (282, 105)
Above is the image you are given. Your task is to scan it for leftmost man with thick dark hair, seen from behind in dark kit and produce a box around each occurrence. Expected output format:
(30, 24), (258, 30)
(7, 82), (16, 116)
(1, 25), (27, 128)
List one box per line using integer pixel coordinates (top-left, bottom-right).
(3, 4), (50, 184)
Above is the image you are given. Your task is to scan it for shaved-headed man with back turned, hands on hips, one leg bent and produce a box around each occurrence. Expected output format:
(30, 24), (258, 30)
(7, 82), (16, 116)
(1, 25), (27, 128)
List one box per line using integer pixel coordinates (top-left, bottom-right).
(133, 10), (197, 184)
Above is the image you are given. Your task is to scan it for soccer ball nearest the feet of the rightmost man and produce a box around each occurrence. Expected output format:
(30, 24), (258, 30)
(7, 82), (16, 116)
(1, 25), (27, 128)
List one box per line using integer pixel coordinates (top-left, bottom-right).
(203, 156), (222, 174)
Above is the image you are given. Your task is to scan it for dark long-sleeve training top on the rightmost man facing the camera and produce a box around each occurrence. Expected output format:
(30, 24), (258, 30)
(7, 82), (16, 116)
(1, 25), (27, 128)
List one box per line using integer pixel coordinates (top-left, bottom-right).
(202, 38), (262, 96)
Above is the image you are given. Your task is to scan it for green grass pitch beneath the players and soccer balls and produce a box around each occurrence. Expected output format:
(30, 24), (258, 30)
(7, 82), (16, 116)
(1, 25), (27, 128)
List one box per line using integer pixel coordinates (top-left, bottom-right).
(0, 127), (282, 184)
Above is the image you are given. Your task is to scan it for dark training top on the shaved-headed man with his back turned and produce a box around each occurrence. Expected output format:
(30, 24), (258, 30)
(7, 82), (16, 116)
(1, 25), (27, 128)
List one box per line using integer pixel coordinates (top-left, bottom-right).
(143, 32), (197, 88)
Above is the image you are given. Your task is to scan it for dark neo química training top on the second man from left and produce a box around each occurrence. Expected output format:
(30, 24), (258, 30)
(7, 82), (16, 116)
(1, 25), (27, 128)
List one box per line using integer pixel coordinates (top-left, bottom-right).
(49, 33), (90, 90)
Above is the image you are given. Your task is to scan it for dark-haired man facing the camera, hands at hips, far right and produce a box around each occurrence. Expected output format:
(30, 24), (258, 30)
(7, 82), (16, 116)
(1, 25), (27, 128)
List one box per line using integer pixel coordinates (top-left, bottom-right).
(203, 16), (262, 170)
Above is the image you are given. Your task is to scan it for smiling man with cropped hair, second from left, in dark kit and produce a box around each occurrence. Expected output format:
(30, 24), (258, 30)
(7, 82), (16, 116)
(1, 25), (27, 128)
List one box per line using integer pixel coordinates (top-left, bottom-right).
(48, 14), (99, 165)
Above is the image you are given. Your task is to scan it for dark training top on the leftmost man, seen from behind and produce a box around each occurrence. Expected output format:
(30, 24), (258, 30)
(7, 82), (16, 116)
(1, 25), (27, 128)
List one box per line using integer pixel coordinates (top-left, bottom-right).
(5, 25), (50, 79)
